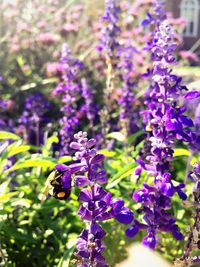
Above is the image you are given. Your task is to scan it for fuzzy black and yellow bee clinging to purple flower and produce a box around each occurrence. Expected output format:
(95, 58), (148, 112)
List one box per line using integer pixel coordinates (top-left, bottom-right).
(41, 170), (71, 202)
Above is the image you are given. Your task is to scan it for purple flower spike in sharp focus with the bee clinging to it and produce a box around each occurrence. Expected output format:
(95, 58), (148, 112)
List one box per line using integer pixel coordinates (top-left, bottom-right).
(56, 132), (133, 267)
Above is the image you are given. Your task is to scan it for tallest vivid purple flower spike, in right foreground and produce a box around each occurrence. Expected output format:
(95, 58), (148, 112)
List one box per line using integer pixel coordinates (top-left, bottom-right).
(127, 1), (194, 249)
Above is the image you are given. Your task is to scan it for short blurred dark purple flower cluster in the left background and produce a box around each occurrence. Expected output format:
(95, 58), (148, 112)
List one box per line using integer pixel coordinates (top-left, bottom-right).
(16, 92), (50, 146)
